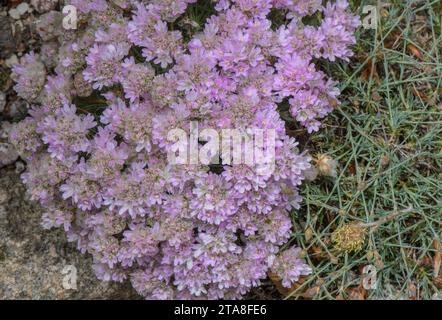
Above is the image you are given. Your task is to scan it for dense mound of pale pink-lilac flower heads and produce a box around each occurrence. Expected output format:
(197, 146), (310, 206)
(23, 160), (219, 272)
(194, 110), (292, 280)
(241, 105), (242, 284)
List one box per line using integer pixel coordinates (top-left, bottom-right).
(11, 0), (359, 299)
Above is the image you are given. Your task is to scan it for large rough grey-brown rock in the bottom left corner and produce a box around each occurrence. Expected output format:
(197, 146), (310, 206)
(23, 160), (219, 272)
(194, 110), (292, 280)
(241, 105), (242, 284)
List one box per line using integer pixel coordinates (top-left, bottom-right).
(0, 168), (139, 300)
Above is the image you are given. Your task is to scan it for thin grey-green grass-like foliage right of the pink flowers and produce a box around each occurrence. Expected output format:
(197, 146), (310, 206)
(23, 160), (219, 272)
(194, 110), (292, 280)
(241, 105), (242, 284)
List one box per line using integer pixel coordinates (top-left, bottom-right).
(286, 1), (442, 299)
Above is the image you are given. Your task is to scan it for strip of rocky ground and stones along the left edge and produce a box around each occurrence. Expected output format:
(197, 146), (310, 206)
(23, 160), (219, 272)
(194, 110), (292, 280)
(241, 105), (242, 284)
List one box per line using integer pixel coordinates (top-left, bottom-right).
(0, 0), (138, 299)
